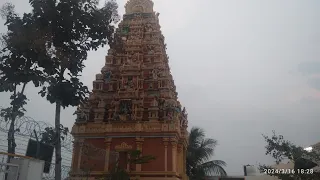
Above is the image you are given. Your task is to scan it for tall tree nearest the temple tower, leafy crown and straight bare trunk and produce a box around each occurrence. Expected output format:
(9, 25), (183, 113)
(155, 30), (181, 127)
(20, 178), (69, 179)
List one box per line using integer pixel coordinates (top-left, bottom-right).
(5, 0), (118, 180)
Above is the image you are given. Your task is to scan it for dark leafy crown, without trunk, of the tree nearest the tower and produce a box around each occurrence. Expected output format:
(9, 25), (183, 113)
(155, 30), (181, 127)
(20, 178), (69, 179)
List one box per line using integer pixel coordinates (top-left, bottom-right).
(30, 0), (119, 107)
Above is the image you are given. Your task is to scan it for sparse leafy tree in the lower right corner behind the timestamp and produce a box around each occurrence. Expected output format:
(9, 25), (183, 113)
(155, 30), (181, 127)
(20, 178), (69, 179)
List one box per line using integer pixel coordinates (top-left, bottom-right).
(259, 131), (320, 180)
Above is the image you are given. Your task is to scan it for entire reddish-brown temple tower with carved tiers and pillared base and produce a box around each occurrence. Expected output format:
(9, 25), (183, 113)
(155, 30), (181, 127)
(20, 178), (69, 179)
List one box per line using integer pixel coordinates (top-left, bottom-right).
(70, 0), (188, 180)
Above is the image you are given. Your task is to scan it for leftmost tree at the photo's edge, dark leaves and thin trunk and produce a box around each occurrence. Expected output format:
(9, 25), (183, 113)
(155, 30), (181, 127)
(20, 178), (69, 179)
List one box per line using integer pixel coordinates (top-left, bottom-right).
(0, 3), (48, 161)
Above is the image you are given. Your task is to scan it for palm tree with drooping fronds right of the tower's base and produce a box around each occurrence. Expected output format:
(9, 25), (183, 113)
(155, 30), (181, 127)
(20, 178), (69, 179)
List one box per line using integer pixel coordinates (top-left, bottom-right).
(187, 127), (227, 180)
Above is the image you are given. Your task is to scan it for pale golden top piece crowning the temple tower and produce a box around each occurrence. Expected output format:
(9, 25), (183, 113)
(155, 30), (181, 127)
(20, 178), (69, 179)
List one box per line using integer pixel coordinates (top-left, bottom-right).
(125, 0), (153, 14)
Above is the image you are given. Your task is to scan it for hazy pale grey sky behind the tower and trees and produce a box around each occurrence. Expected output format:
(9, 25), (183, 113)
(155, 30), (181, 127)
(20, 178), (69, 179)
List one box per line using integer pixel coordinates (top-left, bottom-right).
(0, 0), (320, 175)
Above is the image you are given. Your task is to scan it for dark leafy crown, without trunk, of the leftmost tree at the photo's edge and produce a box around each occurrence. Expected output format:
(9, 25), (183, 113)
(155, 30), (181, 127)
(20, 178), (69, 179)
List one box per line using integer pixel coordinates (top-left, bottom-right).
(0, 4), (48, 89)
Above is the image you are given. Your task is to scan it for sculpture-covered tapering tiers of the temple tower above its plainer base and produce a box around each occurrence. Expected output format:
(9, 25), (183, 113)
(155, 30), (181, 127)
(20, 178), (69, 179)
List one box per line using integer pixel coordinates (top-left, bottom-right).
(73, 0), (188, 135)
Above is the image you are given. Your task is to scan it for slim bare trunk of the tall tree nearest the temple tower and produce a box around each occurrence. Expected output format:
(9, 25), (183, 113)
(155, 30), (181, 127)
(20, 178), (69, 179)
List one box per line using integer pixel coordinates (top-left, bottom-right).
(55, 101), (62, 180)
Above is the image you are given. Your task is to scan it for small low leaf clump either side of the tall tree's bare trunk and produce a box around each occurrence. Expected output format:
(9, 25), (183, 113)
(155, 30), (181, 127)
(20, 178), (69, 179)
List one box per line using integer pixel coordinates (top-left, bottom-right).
(40, 124), (69, 145)
